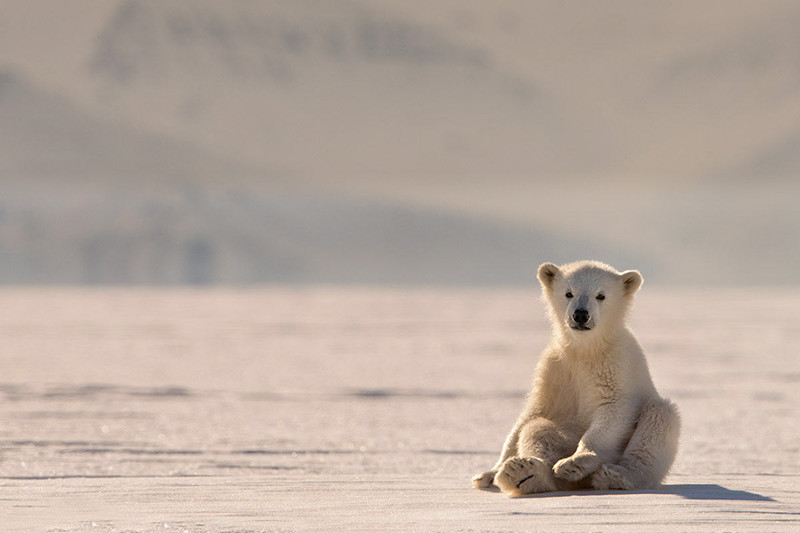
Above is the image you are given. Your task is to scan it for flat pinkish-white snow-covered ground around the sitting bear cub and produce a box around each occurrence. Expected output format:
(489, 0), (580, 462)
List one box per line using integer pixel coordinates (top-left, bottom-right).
(0, 285), (800, 532)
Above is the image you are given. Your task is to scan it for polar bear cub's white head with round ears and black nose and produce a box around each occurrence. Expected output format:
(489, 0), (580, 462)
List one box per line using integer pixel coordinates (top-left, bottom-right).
(538, 261), (642, 339)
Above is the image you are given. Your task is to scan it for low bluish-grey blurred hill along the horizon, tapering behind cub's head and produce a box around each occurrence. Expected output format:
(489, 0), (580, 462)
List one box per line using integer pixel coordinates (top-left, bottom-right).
(0, 186), (646, 285)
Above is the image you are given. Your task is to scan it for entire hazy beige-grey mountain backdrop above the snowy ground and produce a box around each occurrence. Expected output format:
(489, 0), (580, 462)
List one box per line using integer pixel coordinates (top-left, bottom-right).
(0, 0), (800, 286)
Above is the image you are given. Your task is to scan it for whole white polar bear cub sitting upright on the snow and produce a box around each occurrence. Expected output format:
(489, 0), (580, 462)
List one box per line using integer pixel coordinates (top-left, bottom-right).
(472, 261), (680, 496)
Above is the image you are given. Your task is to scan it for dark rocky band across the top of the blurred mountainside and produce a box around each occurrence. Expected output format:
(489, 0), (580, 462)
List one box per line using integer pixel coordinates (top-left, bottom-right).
(92, 0), (487, 84)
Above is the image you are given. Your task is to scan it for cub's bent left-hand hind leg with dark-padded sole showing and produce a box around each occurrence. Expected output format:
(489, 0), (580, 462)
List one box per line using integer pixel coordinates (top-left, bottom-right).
(494, 418), (579, 496)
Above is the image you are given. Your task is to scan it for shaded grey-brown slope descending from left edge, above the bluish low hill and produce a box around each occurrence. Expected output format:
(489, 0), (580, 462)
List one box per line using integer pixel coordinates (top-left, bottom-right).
(0, 70), (264, 188)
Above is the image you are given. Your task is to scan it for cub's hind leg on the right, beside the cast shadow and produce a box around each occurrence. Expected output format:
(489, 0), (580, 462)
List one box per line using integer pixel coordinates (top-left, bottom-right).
(592, 399), (680, 490)
